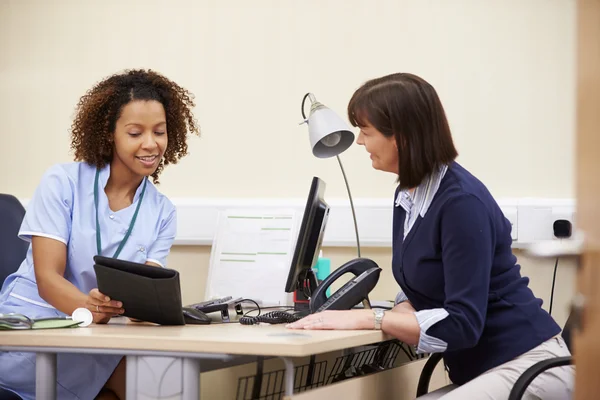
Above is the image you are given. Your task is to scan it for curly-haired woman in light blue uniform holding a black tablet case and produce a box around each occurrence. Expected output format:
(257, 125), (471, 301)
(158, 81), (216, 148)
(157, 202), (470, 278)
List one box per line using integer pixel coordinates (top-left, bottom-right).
(0, 70), (198, 400)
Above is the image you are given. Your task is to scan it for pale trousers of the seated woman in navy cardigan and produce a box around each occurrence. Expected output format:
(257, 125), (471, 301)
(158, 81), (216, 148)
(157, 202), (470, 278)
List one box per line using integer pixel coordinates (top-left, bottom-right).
(419, 336), (575, 400)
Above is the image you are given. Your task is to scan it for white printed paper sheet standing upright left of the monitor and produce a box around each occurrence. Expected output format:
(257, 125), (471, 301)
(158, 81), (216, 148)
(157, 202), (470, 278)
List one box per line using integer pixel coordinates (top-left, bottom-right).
(205, 209), (298, 307)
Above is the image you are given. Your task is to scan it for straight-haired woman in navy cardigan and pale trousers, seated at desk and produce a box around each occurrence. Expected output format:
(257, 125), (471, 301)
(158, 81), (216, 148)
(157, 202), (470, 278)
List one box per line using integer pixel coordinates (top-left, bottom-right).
(290, 73), (573, 400)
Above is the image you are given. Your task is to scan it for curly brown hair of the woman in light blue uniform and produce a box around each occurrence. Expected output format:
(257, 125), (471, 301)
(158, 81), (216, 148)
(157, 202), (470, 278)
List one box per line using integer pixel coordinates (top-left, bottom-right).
(71, 70), (200, 183)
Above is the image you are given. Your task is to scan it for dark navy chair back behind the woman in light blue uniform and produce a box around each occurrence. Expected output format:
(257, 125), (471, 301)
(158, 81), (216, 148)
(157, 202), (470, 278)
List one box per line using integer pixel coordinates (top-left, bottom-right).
(0, 193), (29, 287)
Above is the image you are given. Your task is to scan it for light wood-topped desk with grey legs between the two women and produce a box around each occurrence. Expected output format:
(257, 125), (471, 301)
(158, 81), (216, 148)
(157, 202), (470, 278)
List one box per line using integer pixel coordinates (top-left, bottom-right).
(0, 319), (389, 400)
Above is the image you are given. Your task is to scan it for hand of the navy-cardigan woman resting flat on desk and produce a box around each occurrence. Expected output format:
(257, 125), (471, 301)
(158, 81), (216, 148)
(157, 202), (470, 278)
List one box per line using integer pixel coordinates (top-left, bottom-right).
(286, 310), (375, 330)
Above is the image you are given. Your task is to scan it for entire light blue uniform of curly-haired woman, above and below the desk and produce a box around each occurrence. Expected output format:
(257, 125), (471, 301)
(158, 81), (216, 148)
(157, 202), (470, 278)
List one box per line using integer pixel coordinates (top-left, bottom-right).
(0, 163), (177, 400)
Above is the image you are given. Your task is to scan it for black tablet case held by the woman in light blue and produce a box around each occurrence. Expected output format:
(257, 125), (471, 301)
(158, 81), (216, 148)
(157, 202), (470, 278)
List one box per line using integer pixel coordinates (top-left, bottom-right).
(94, 256), (185, 325)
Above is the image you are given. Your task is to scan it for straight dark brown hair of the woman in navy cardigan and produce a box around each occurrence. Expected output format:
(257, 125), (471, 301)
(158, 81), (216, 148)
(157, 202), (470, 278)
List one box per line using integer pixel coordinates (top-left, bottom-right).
(348, 73), (458, 189)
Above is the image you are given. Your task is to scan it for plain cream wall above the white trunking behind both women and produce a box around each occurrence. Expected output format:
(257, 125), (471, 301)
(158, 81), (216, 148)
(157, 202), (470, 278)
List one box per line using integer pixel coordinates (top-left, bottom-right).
(0, 0), (575, 198)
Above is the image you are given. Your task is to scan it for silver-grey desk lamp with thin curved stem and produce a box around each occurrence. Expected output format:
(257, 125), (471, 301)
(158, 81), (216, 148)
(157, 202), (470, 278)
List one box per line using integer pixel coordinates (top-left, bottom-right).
(301, 93), (360, 257)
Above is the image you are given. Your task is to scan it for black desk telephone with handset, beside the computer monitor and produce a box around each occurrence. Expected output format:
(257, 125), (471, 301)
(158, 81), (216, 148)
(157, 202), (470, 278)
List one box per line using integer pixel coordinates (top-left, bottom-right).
(310, 258), (381, 314)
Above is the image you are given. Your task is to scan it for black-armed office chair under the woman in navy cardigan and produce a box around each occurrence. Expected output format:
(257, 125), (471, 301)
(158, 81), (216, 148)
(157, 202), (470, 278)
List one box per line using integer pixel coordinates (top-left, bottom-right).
(417, 314), (574, 400)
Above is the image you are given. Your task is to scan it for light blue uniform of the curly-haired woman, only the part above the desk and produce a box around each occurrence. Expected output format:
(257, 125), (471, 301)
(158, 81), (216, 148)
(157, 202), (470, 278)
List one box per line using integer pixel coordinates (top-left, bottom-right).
(0, 162), (177, 318)
